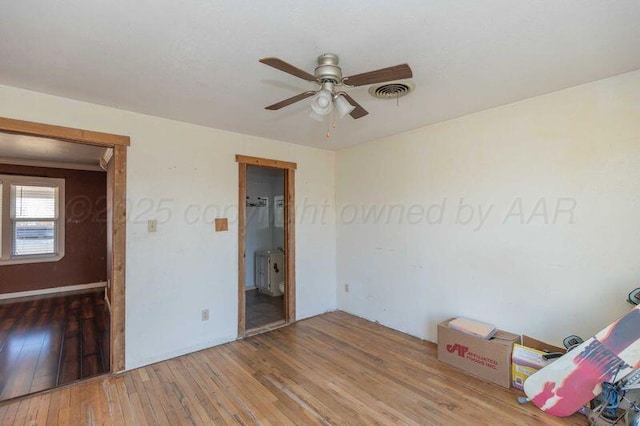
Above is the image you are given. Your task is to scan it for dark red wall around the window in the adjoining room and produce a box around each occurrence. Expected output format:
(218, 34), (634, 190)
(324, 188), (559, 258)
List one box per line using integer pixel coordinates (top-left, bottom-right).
(0, 164), (107, 294)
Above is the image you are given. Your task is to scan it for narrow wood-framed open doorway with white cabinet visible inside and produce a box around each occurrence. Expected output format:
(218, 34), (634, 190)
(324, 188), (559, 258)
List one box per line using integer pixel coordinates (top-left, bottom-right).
(236, 155), (295, 336)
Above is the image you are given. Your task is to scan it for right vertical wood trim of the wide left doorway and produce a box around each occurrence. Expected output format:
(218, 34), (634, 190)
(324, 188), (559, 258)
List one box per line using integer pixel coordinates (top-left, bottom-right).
(110, 146), (127, 372)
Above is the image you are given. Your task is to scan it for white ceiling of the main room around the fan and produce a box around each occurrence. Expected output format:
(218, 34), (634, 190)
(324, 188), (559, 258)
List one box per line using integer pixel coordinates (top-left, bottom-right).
(0, 0), (640, 149)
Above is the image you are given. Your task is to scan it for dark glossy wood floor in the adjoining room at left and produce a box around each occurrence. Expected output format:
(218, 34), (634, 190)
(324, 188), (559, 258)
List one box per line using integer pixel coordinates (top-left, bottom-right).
(0, 289), (109, 402)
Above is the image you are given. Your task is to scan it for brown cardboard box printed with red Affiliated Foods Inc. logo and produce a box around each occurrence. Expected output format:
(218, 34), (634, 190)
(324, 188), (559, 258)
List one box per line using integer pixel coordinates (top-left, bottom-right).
(438, 318), (520, 388)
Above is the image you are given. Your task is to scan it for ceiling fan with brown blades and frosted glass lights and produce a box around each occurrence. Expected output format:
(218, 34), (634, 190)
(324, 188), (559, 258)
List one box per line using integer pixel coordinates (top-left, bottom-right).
(260, 53), (413, 121)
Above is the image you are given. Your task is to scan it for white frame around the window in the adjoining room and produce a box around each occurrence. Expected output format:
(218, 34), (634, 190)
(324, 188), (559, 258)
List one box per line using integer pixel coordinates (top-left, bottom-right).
(0, 175), (66, 265)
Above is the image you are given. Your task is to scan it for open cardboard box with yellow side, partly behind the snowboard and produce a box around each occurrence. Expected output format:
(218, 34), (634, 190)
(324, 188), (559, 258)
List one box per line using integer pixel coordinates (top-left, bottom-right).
(511, 336), (566, 390)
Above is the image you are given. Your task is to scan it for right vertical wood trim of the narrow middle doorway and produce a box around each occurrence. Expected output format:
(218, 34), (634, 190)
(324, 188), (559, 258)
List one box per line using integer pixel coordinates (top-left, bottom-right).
(284, 169), (296, 323)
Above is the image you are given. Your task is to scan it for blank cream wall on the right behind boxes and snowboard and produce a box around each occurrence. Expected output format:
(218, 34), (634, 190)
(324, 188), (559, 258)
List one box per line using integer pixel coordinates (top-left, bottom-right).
(336, 72), (640, 343)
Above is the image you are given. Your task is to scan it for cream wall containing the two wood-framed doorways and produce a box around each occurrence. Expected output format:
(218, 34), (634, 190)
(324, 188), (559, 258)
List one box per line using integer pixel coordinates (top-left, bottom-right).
(0, 86), (336, 368)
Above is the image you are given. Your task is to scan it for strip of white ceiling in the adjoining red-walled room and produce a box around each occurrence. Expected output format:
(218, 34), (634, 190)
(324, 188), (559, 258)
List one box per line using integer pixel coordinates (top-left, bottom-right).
(0, 132), (111, 170)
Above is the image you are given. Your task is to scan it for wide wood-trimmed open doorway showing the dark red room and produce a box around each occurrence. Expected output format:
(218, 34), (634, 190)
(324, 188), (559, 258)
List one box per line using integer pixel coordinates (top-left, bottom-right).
(0, 117), (129, 400)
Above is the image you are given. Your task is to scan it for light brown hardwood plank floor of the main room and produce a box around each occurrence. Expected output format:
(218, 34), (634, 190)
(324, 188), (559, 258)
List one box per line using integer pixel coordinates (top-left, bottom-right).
(0, 312), (587, 425)
